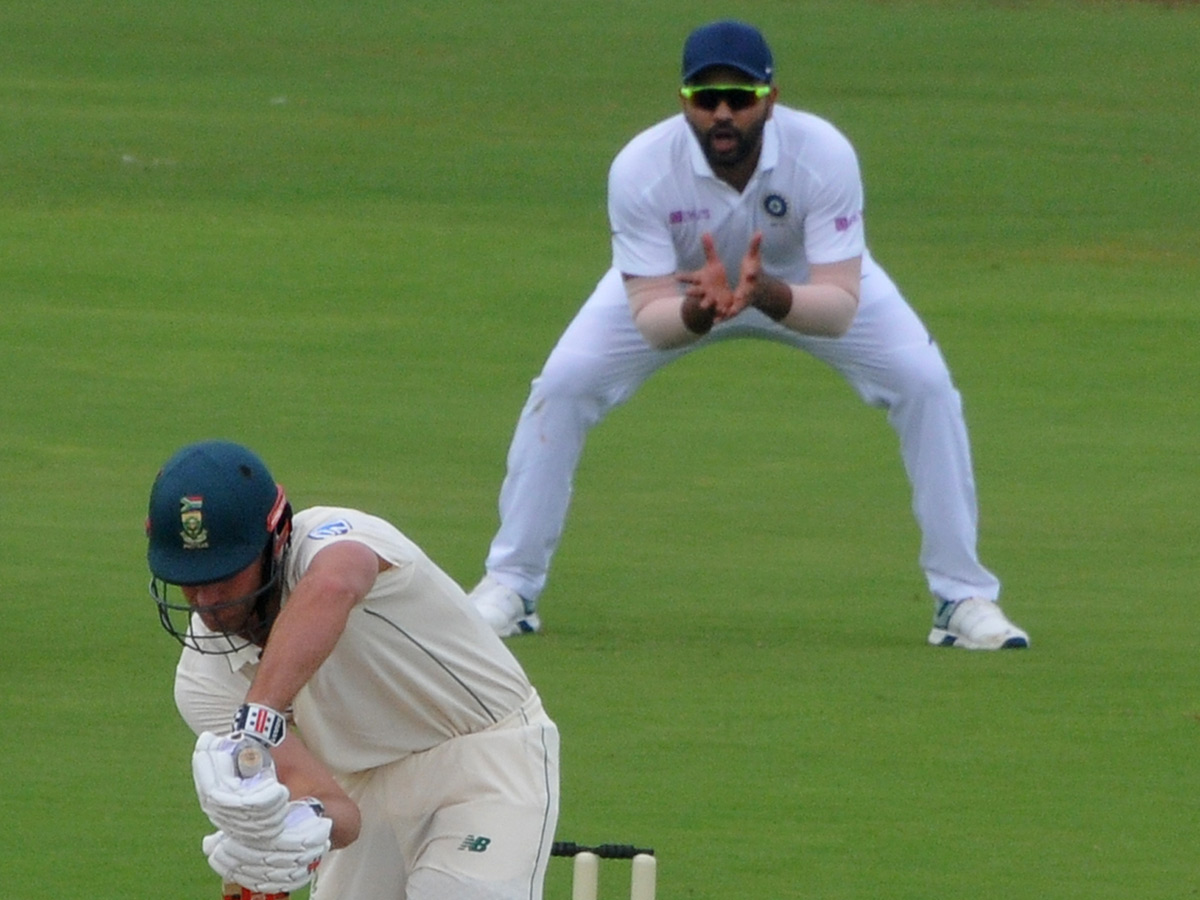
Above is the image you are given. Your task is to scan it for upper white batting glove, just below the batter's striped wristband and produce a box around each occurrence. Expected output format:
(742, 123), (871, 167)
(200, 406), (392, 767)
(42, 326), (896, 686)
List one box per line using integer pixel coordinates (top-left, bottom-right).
(192, 731), (292, 846)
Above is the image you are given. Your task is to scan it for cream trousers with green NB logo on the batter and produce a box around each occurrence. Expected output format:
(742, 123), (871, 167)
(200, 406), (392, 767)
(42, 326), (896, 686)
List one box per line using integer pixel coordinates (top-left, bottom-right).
(312, 692), (559, 900)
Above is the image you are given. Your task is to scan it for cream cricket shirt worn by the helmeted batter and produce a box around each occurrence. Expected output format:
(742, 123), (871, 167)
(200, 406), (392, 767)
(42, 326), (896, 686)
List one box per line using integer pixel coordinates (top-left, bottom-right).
(175, 506), (534, 773)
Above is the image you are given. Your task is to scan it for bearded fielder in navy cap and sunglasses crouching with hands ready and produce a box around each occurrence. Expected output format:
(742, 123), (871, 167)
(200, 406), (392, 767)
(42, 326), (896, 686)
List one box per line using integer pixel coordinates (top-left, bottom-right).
(472, 22), (1028, 649)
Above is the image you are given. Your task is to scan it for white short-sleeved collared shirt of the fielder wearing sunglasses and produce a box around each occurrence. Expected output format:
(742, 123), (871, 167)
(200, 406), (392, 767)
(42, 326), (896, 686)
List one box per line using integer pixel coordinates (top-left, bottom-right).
(608, 104), (874, 290)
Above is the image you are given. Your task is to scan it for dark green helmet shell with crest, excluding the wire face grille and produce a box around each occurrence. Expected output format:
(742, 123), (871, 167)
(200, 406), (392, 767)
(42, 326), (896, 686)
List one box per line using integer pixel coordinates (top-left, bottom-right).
(146, 440), (287, 584)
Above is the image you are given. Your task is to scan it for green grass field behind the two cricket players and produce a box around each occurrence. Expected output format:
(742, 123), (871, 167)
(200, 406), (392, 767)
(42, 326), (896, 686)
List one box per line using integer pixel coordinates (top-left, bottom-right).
(0, 0), (1200, 900)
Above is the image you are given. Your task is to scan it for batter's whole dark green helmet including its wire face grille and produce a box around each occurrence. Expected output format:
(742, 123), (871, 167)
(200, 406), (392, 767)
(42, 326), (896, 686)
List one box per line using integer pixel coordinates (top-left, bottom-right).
(146, 440), (292, 653)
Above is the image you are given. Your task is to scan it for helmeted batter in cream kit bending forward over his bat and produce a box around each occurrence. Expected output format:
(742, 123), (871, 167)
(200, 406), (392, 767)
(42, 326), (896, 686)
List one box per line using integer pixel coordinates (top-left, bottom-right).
(146, 442), (559, 900)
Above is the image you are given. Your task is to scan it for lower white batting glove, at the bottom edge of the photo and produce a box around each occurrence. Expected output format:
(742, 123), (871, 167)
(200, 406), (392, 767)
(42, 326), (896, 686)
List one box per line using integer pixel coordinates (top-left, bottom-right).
(203, 802), (334, 893)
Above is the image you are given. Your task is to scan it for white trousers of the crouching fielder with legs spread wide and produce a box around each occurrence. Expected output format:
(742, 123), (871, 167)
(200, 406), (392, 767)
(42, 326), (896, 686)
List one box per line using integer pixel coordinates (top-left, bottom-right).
(486, 268), (1000, 600)
